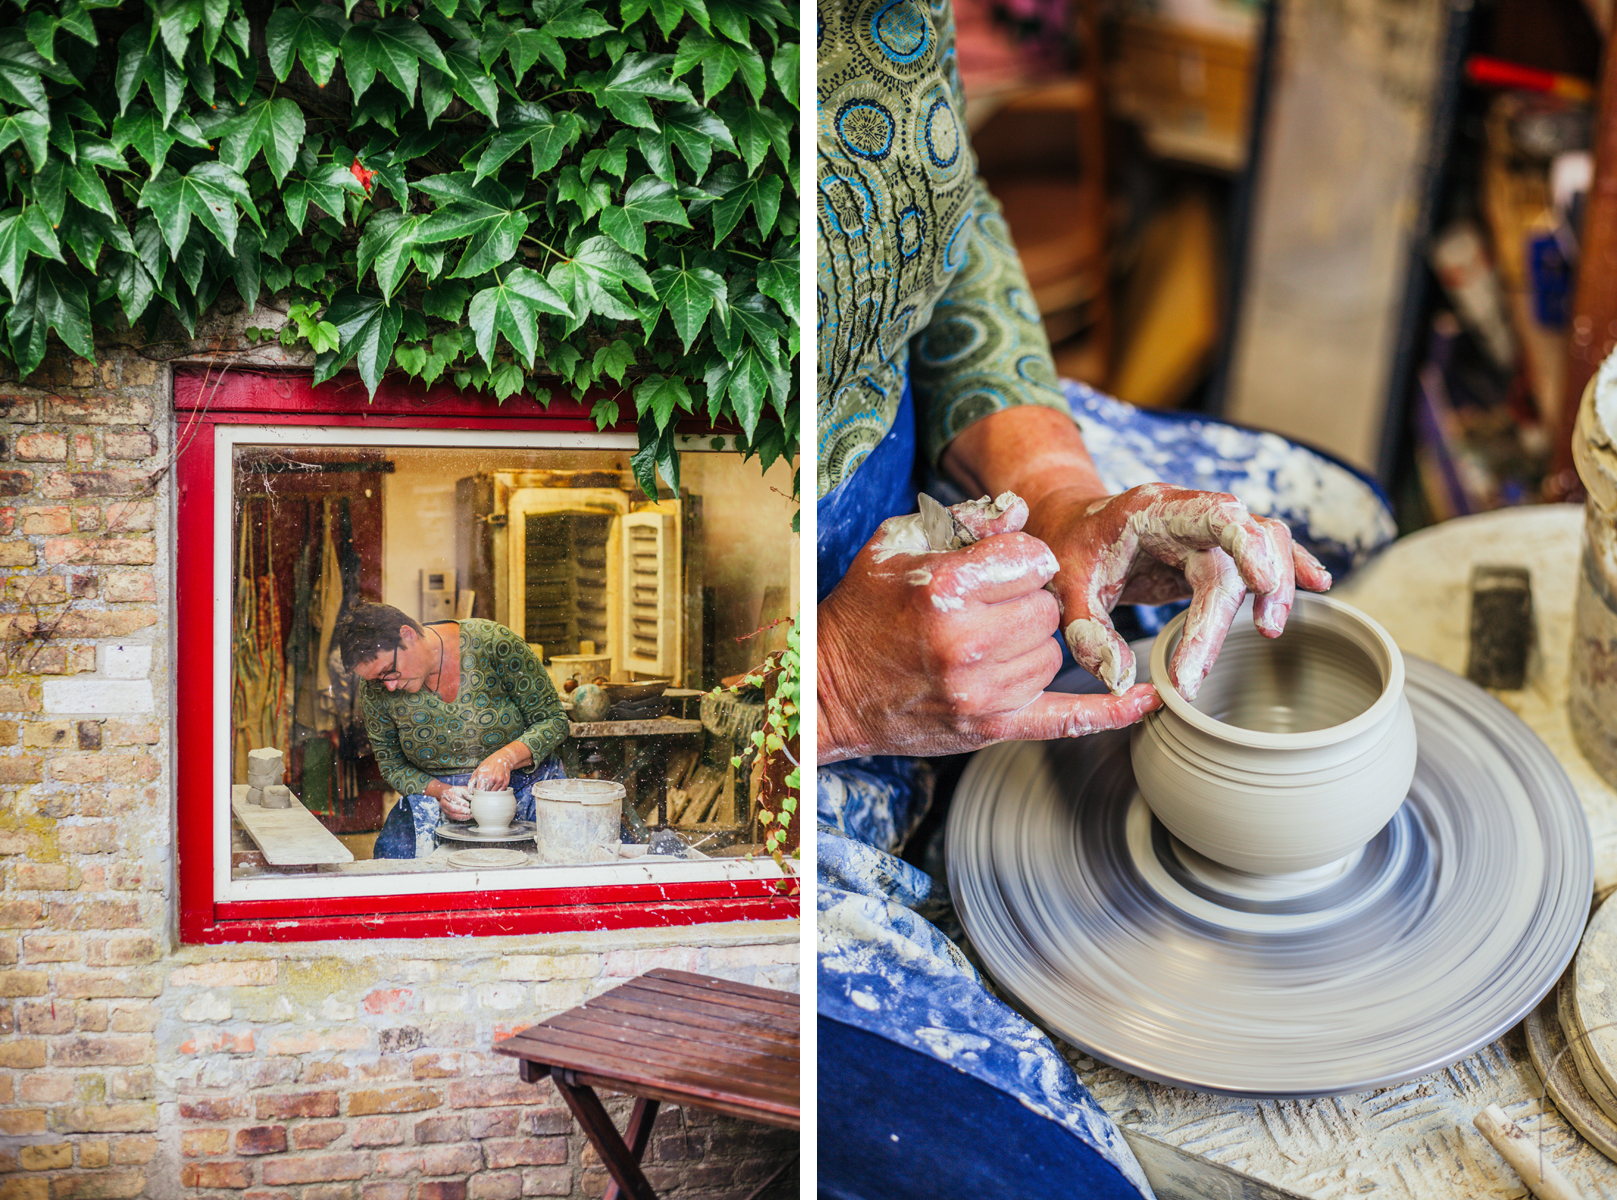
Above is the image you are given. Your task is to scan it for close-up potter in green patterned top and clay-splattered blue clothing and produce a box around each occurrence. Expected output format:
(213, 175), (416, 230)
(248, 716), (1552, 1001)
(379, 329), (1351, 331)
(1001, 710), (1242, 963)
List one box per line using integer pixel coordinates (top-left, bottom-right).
(817, 3), (1392, 1197)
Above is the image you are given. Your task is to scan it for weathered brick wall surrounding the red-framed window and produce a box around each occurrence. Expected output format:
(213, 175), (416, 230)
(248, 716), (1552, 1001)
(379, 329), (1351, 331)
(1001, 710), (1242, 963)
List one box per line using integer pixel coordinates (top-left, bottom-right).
(0, 351), (797, 1200)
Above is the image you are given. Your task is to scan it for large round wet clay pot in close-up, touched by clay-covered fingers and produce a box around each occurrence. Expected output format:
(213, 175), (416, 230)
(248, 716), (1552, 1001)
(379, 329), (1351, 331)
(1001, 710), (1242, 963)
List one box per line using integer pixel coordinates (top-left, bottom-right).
(1130, 594), (1415, 875)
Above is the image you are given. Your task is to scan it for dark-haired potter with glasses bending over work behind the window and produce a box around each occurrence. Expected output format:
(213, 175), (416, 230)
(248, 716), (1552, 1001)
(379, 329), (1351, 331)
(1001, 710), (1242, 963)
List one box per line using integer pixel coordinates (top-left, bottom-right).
(335, 603), (568, 859)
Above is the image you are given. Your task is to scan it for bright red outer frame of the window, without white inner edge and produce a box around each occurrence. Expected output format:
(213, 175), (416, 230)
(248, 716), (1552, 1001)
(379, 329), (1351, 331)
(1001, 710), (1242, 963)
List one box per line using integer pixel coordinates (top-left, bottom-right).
(173, 367), (799, 944)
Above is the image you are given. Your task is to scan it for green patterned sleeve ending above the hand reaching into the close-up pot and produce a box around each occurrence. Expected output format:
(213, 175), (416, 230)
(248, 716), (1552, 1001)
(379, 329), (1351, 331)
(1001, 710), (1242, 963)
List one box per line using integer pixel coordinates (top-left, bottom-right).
(910, 180), (1072, 463)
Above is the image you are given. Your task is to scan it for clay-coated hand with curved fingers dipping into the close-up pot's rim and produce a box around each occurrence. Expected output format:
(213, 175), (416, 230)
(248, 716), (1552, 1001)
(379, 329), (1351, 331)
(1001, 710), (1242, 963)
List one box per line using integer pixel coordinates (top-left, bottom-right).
(1028, 484), (1331, 700)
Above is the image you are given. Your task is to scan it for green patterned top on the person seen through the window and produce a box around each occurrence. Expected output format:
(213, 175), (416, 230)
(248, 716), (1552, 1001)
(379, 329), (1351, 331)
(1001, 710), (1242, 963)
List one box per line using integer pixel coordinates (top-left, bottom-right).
(364, 618), (568, 796)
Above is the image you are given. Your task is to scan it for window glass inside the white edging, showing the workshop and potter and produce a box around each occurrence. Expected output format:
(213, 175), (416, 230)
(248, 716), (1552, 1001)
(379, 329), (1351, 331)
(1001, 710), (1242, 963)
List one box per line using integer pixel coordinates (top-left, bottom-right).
(230, 445), (797, 886)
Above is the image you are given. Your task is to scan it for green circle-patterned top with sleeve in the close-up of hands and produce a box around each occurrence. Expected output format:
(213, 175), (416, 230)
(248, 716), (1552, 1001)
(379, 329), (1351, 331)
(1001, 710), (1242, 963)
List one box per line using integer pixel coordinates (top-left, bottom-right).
(818, 0), (1070, 496)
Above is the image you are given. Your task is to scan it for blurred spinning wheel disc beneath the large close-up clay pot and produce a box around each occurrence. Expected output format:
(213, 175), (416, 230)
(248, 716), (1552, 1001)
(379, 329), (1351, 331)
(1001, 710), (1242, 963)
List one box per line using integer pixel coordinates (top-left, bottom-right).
(948, 655), (1593, 1096)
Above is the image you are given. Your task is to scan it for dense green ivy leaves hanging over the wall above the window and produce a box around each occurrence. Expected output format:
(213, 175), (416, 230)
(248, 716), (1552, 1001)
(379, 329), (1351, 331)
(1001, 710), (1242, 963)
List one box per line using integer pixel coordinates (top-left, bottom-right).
(0, 0), (799, 492)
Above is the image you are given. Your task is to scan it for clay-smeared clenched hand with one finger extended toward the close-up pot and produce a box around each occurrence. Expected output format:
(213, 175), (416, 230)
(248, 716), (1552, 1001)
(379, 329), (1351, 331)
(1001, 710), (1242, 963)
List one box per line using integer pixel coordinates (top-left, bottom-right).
(817, 493), (1161, 762)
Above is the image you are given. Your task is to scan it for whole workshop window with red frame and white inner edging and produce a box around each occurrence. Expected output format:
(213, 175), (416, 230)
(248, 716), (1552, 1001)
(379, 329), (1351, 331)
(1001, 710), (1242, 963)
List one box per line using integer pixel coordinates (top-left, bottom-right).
(175, 370), (797, 941)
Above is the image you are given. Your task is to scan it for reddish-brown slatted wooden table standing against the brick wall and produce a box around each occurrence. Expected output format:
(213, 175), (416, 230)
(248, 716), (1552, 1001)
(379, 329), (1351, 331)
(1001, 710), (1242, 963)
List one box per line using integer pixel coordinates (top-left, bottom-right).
(493, 969), (802, 1200)
